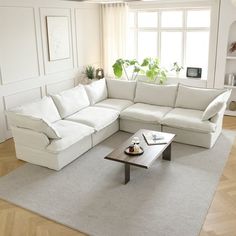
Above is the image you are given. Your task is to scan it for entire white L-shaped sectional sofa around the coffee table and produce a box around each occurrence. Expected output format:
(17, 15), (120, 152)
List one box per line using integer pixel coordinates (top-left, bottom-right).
(7, 79), (231, 170)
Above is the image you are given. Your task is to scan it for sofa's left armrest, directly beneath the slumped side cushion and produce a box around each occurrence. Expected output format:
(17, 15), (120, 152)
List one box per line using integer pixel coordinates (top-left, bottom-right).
(11, 126), (50, 150)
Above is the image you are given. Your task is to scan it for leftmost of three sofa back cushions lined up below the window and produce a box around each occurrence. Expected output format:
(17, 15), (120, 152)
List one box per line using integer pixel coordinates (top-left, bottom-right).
(107, 79), (136, 101)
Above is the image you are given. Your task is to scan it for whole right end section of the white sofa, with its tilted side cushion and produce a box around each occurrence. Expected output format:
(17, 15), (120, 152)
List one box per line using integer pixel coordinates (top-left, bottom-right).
(162, 85), (231, 148)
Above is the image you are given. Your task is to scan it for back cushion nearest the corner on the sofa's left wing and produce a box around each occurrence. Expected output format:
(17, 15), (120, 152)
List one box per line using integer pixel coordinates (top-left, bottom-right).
(84, 79), (107, 105)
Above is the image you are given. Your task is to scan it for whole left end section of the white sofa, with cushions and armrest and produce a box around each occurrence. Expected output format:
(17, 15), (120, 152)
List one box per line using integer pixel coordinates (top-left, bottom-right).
(7, 97), (95, 170)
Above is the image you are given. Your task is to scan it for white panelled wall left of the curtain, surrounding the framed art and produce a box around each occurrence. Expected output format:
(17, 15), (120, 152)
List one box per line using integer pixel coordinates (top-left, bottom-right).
(0, 0), (101, 142)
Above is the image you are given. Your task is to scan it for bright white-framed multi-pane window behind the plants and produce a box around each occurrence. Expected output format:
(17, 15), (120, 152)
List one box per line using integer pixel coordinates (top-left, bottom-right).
(127, 8), (210, 78)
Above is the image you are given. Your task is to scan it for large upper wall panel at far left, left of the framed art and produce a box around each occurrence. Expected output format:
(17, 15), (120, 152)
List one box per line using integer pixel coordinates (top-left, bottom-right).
(0, 6), (39, 84)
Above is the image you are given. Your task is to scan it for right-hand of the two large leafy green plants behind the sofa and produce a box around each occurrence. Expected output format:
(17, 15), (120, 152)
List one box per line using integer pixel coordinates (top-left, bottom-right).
(140, 57), (167, 84)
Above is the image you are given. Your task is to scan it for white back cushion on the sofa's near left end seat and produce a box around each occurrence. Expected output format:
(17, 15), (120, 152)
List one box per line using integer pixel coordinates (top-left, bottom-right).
(11, 97), (61, 122)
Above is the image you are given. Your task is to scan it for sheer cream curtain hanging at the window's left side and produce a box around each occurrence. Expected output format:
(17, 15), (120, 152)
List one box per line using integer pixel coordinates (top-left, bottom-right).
(101, 3), (128, 75)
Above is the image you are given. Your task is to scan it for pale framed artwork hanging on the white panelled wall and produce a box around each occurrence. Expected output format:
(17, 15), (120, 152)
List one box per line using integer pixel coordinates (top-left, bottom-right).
(46, 16), (70, 61)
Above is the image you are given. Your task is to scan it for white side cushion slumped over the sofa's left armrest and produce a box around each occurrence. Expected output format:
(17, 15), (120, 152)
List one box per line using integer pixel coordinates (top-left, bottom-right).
(7, 111), (61, 139)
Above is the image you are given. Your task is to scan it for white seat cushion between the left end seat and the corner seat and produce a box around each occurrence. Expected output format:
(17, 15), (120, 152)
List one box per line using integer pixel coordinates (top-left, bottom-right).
(66, 107), (119, 131)
